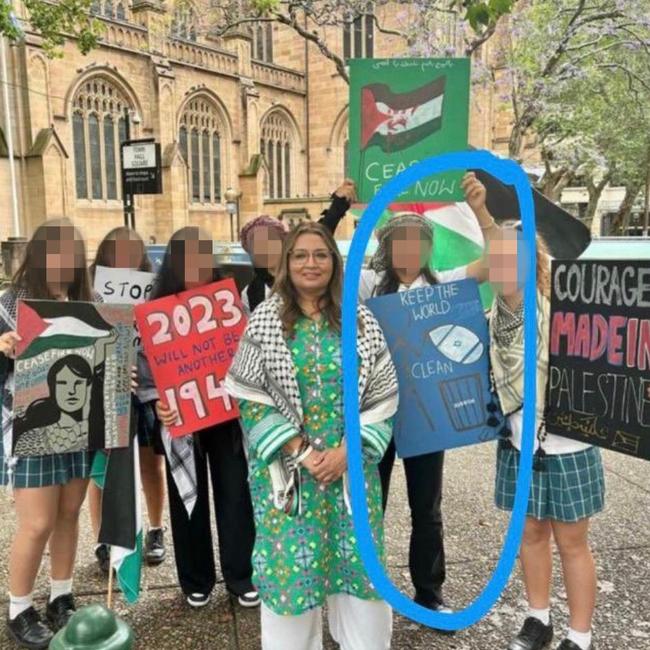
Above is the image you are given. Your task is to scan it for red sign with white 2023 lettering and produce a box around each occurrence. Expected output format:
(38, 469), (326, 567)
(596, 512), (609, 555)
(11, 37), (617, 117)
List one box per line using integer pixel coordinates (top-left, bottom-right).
(135, 279), (246, 436)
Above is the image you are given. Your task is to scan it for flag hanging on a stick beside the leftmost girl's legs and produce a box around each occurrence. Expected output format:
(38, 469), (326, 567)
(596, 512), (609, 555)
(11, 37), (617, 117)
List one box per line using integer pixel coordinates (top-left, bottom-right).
(91, 439), (142, 604)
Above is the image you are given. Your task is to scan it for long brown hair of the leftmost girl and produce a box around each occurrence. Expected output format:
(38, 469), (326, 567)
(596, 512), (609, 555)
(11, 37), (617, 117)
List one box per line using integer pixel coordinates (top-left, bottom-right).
(12, 218), (92, 302)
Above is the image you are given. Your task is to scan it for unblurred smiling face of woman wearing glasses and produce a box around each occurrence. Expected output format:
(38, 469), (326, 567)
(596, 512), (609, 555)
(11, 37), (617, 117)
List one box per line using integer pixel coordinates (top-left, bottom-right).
(289, 233), (334, 296)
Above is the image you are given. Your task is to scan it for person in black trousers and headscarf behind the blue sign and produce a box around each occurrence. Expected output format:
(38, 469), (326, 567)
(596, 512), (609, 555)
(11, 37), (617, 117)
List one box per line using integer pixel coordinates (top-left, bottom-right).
(359, 173), (496, 611)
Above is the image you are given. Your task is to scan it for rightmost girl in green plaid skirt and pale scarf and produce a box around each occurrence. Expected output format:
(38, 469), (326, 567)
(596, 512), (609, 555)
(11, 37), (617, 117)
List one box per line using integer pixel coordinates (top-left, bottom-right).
(488, 223), (605, 650)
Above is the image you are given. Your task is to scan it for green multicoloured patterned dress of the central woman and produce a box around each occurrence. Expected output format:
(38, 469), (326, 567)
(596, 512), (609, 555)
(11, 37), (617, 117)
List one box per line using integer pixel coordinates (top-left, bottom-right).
(239, 317), (392, 616)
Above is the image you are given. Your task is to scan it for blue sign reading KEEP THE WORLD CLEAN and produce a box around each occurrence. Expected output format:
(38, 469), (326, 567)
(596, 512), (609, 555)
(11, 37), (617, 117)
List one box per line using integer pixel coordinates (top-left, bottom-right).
(366, 280), (504, 458)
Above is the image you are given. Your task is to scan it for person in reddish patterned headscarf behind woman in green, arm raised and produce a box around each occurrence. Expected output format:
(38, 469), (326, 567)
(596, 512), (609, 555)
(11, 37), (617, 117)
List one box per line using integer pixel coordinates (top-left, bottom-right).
(241, 178), (356, 314)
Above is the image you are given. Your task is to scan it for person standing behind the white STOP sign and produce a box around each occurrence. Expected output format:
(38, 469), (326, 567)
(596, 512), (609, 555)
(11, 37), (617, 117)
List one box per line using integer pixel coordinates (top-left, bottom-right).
(88, 226), (166, 573)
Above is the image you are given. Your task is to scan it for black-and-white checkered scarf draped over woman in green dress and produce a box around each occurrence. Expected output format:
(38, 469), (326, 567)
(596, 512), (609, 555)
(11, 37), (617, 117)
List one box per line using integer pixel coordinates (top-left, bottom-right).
(225, 295), (398, 508)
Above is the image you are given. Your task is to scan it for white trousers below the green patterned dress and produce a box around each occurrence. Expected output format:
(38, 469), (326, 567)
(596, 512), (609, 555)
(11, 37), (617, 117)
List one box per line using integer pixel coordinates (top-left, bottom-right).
(261, 594), (393, 650)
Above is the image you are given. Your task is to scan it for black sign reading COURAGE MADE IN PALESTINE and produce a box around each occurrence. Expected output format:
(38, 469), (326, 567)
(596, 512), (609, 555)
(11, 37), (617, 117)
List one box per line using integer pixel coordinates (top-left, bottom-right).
(546, 260), (650, 460)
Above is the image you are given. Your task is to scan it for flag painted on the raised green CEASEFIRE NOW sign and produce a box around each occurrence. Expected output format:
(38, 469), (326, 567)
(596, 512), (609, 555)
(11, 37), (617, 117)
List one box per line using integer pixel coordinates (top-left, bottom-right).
(359, 76), (446, 153)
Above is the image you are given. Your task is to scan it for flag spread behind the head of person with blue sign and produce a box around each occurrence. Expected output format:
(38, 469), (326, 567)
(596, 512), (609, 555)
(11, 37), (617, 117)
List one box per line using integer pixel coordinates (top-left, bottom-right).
(351, 202), (493, 309)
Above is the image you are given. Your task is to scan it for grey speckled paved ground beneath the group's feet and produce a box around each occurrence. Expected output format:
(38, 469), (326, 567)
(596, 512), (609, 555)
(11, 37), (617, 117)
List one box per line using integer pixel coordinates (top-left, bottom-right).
(0, 445), (650, 650)
